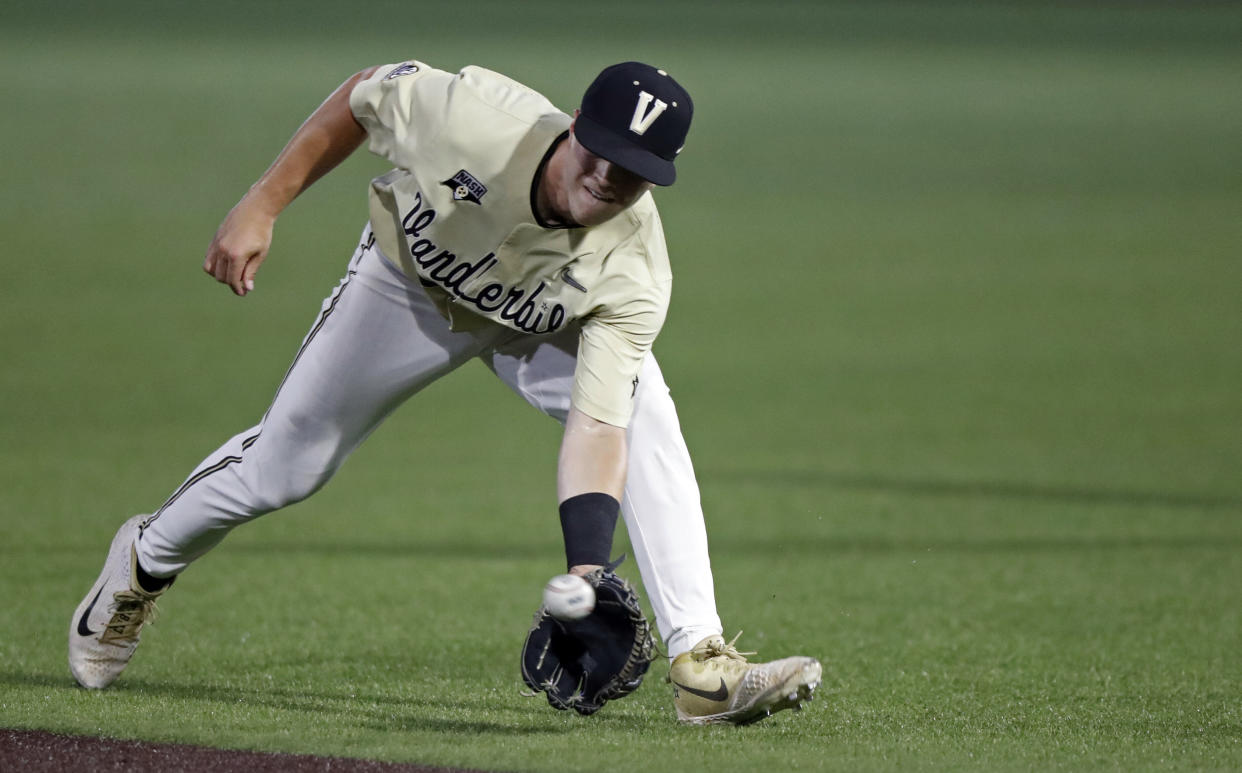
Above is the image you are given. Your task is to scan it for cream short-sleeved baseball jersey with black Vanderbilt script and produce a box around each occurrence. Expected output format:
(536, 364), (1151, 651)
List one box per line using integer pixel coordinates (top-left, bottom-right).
(349, 61), (672, 426)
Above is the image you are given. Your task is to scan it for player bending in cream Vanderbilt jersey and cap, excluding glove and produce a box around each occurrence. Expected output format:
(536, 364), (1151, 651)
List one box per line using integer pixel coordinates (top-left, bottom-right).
(68, 55), (821, 723)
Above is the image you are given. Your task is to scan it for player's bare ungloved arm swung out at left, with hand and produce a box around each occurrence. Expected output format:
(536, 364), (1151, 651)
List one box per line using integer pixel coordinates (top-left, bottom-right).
(202, 67), (376, 296)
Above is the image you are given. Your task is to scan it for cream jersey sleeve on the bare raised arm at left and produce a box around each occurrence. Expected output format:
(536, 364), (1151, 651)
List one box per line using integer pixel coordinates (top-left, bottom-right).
(349, 61), (456, 169)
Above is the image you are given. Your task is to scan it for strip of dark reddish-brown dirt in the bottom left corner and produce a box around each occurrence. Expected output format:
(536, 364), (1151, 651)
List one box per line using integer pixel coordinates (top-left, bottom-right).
(0, 730), (489, 773)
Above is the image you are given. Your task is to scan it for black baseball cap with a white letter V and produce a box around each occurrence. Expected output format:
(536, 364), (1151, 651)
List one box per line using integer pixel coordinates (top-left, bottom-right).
(574, 62), (694, 185)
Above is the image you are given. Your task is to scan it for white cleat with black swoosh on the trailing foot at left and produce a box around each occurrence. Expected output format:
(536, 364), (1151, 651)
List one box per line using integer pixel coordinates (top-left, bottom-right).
(70, 516), (171, 690)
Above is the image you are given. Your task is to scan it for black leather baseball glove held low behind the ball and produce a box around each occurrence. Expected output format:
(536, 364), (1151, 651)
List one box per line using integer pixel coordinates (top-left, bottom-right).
(522, 557), (656, 716)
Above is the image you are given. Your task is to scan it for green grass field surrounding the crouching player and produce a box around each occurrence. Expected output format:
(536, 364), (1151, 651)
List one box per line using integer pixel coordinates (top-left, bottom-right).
(0, 0), (1242, 771)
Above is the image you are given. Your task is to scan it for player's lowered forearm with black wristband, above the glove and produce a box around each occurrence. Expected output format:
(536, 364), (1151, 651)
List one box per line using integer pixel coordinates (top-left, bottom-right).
(556, 408), (627, 574)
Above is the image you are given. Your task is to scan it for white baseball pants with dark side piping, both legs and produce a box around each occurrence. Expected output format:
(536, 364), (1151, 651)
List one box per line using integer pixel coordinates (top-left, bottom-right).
(137, 227), (722, 657)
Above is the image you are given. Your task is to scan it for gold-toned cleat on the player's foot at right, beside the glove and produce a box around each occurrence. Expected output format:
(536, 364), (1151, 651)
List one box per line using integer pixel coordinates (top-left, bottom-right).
(668, 633), (823, 725)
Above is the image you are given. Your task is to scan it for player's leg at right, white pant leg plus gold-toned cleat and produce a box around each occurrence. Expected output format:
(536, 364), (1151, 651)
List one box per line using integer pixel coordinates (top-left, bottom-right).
(481, 328), (822, 725)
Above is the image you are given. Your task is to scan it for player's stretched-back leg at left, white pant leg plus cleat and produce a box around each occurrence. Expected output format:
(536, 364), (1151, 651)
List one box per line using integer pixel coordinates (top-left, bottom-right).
(70, 230), (499, 687)
